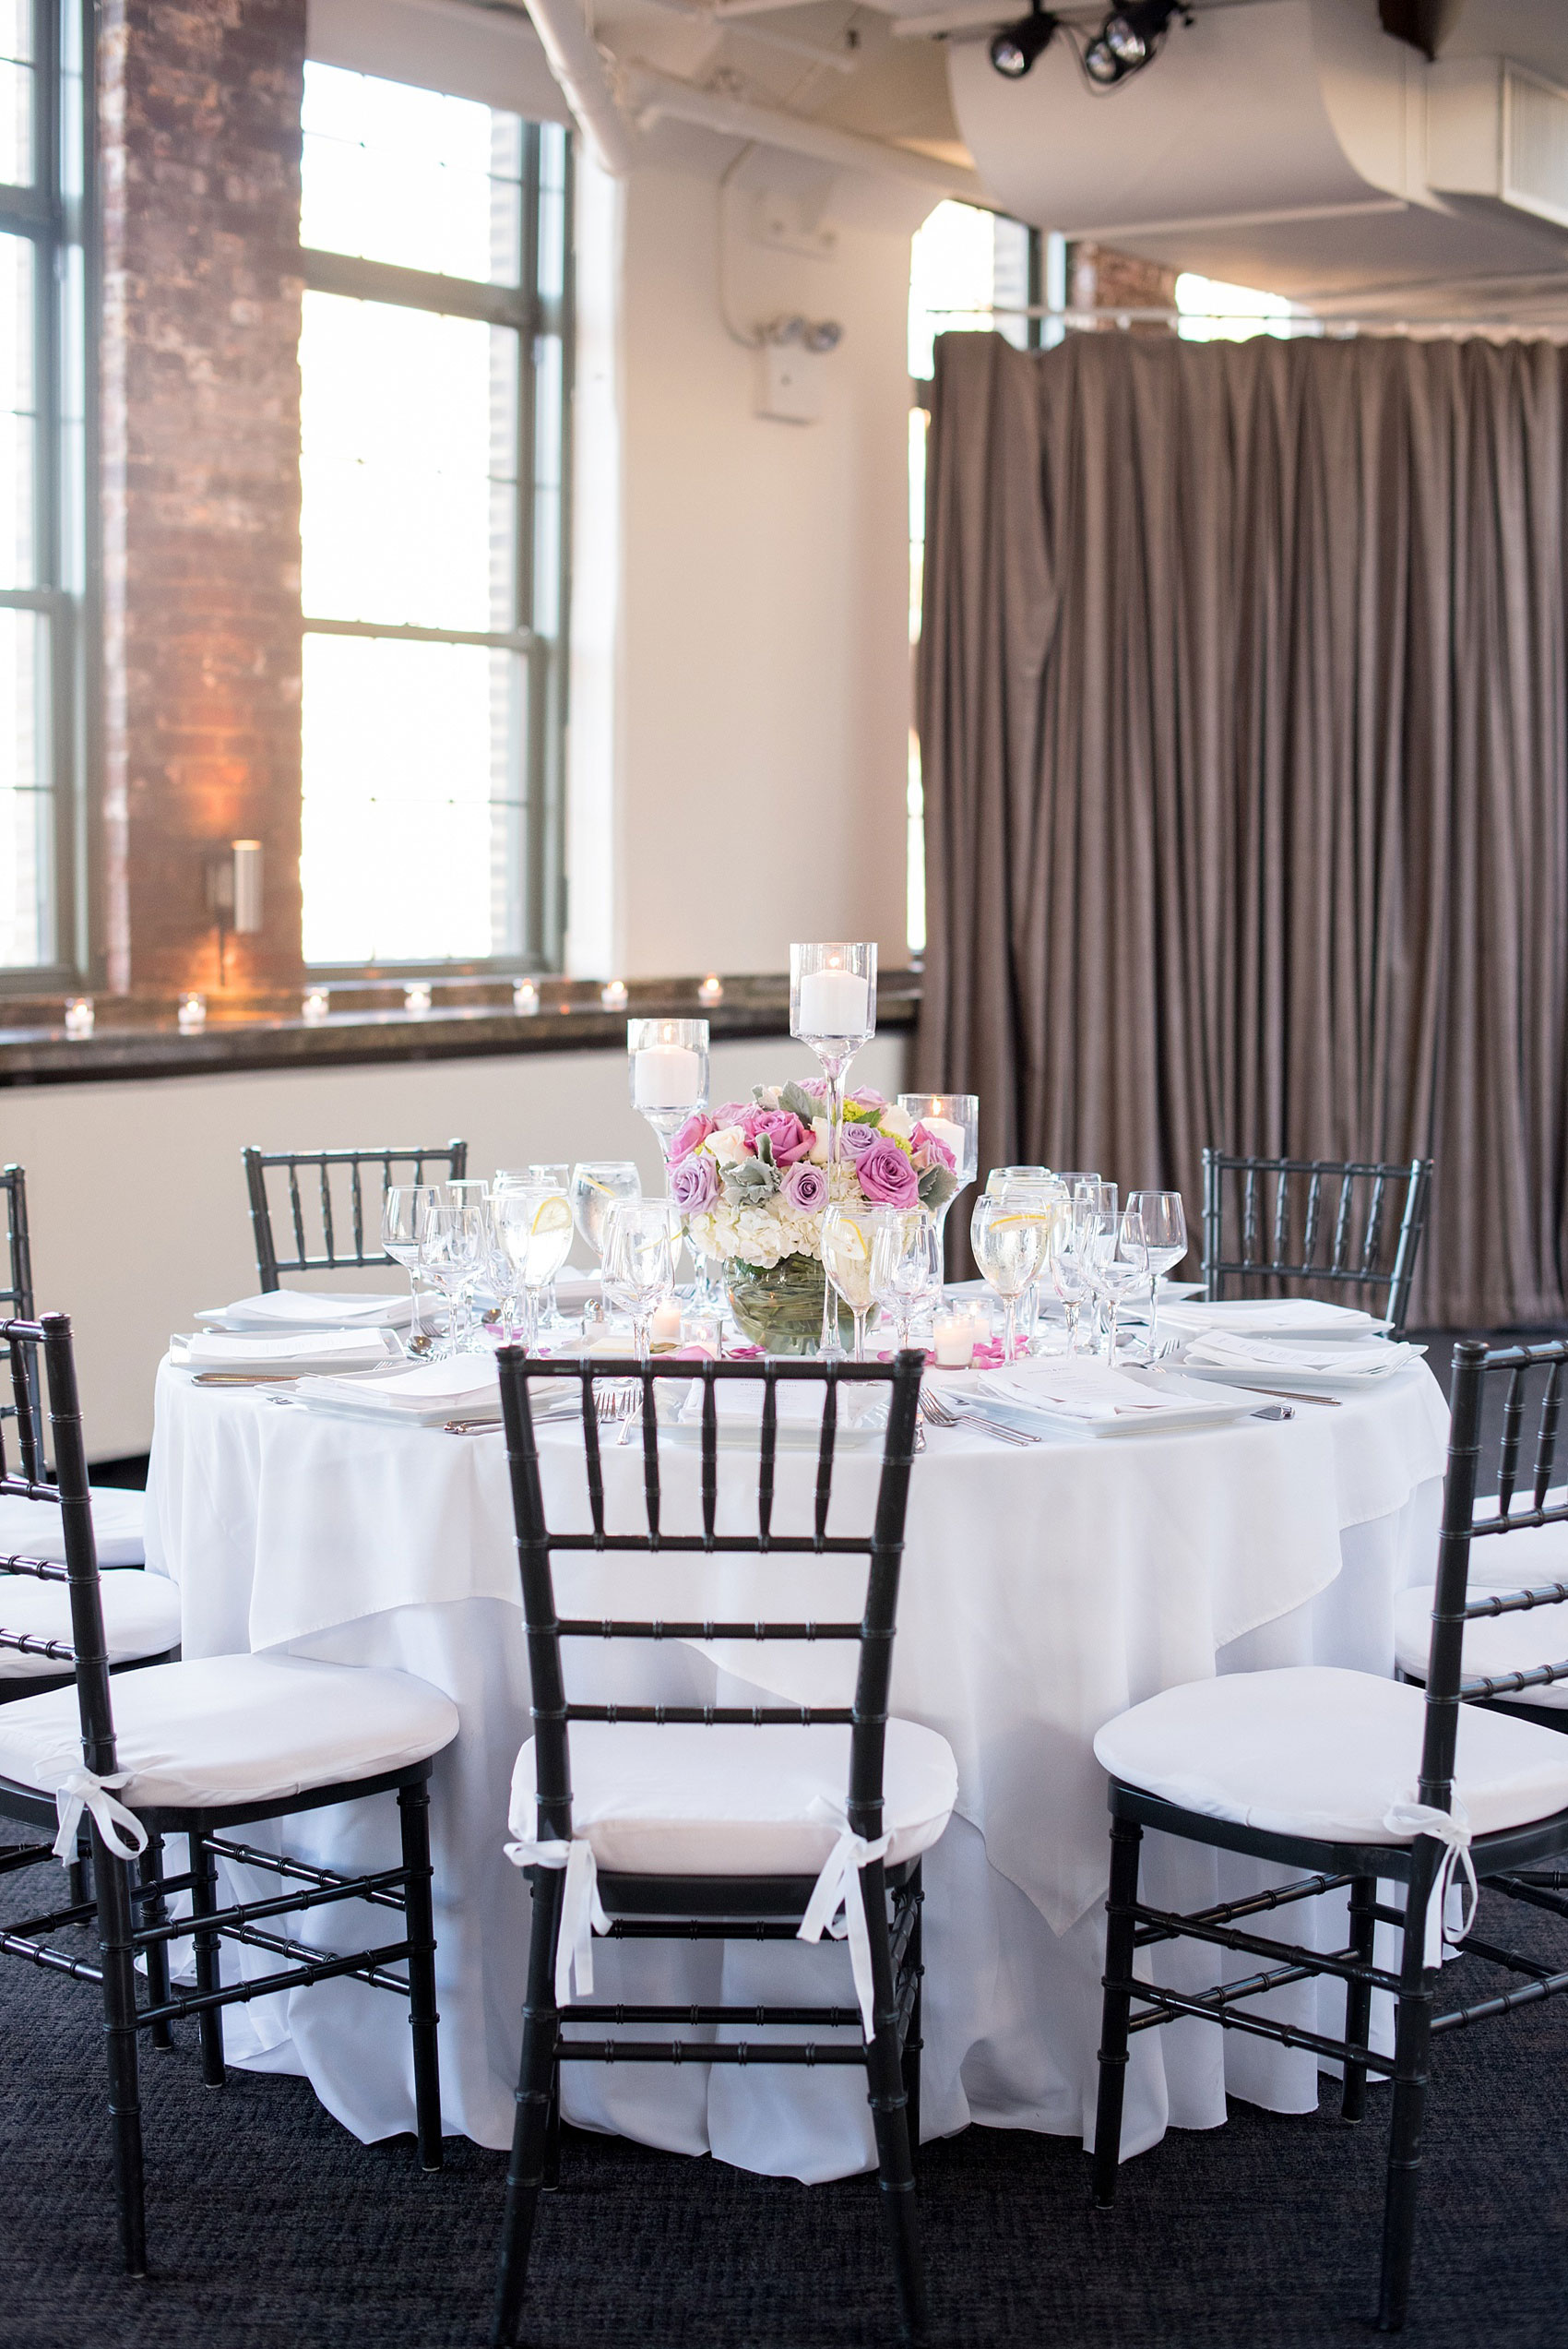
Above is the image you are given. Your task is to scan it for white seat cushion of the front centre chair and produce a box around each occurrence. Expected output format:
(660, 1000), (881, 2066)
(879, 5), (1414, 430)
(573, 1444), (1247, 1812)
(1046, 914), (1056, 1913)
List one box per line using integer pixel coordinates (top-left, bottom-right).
(509, 1722), (957, 1877)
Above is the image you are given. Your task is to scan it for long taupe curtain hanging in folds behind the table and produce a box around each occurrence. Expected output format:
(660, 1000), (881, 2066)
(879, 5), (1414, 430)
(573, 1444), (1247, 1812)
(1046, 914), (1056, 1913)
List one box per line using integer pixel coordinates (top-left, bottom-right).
(918, 334), (1568, 1325)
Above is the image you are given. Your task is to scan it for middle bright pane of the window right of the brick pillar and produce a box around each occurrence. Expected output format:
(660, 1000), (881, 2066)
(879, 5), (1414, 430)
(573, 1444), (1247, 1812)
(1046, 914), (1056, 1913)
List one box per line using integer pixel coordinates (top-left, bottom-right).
(301, 293), (518, 632)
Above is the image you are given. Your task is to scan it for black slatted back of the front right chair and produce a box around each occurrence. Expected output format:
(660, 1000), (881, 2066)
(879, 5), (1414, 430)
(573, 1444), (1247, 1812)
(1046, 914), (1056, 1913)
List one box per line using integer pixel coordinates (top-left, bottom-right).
(1420, 1339), (1568, 1811)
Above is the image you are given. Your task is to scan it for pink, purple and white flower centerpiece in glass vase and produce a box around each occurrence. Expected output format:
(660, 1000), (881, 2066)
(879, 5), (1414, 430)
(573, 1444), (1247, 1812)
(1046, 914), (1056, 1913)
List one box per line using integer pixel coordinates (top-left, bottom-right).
(669, 1079), (962, 1353)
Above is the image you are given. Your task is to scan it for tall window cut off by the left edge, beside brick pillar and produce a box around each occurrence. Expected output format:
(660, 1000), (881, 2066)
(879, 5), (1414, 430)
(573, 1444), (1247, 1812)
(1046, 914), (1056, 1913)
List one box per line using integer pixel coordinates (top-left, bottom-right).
(0, 0), (85, 984)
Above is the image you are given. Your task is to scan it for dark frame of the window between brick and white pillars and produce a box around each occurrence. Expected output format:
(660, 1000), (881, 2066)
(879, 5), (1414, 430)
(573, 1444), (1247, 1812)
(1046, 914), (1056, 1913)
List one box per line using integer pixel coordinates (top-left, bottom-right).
(301, 101), (576, 986)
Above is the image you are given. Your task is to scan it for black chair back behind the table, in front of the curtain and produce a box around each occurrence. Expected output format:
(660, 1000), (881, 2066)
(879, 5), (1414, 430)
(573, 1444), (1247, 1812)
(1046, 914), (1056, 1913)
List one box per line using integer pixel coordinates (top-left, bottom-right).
(1205, 1149), (1431, 1337)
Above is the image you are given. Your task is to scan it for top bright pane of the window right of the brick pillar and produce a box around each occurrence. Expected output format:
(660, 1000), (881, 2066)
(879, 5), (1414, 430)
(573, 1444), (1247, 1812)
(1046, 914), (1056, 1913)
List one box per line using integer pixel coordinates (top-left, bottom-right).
(301, 64), (524, 287)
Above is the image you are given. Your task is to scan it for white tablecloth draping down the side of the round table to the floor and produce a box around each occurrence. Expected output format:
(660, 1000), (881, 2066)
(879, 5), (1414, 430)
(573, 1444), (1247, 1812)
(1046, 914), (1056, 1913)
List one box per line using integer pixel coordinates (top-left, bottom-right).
(146, 1363), (1448, 2180)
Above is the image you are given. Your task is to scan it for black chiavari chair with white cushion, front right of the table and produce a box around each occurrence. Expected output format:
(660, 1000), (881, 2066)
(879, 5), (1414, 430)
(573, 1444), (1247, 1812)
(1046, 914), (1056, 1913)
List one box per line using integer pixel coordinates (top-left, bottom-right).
(1094, 1341), (1568, 2332)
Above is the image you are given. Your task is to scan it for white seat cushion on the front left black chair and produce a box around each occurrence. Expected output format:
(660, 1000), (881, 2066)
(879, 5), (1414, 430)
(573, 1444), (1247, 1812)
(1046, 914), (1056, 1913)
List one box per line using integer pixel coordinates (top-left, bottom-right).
(0, 1656), (457, 1811)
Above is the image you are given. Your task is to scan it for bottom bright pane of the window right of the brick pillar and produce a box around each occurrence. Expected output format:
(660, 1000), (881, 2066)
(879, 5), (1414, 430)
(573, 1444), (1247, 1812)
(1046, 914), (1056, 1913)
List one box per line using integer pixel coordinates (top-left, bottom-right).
(301, 634), (526, 963)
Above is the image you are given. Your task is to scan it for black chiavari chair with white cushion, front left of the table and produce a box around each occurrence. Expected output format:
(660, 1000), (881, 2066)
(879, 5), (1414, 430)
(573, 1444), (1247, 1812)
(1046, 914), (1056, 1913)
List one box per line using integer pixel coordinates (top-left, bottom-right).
(0, 1313), (457, 2276)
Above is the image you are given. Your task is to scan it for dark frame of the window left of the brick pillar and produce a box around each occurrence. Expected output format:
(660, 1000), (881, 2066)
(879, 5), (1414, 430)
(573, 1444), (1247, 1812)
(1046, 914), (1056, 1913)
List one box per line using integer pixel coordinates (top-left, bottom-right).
(0, 0), (99, 996)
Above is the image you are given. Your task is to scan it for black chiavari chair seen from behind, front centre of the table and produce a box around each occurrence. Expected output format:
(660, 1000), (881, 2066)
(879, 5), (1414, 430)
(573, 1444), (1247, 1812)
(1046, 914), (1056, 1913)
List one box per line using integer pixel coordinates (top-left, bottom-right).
(493, 1348), (957, 2344)
